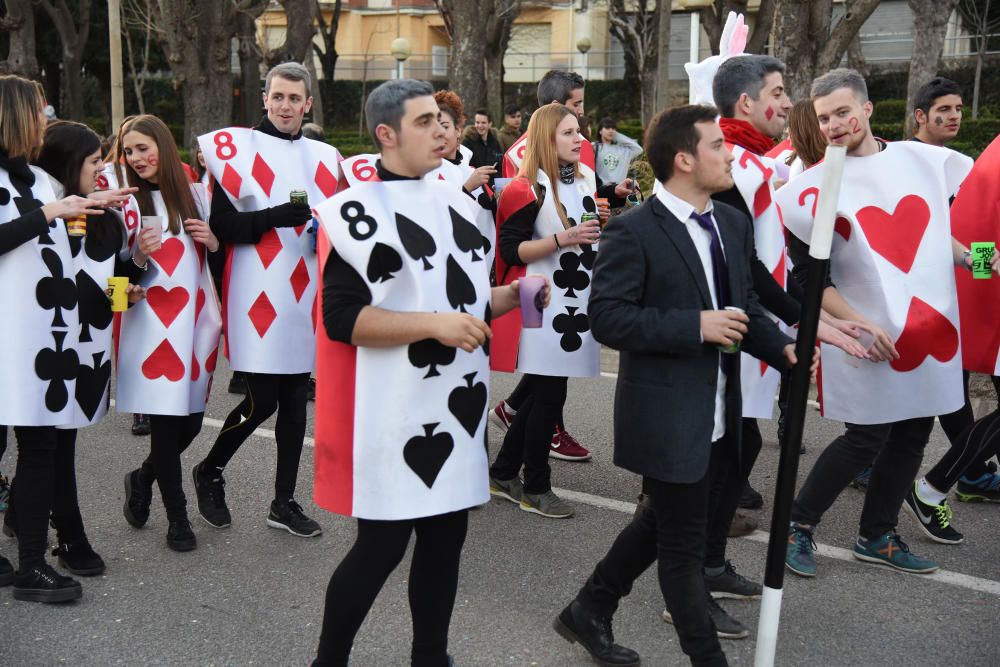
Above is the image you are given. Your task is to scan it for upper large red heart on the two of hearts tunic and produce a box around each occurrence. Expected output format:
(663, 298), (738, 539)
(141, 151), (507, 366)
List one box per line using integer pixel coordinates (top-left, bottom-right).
(857, 195), (931, 273)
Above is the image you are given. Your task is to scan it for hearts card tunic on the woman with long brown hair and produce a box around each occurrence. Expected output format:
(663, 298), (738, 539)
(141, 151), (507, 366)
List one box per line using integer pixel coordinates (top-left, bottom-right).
(115, 184), (222, 416)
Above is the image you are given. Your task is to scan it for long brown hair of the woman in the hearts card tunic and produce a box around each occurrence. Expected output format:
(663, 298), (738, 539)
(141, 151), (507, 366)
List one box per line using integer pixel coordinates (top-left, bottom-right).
(115, 114), (201, 234)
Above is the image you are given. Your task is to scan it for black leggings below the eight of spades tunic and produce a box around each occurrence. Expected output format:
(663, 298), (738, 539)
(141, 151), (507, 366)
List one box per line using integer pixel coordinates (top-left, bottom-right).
(313, 510), (469, 667)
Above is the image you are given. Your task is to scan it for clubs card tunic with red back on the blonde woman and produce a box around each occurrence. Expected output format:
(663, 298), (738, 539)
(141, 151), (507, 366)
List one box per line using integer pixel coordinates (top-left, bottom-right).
(491, 171), (600, 377)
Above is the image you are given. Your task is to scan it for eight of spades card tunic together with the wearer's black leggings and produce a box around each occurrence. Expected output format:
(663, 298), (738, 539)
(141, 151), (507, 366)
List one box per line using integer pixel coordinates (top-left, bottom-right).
(314, 159), (491, 665)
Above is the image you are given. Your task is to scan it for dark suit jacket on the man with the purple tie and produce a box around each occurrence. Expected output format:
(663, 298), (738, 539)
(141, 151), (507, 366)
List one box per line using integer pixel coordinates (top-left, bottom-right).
(589, 197), (793, 483)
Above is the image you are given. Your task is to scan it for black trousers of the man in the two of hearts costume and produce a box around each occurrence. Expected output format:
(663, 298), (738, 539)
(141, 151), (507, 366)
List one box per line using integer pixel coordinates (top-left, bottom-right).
(792, 417), (934, 539)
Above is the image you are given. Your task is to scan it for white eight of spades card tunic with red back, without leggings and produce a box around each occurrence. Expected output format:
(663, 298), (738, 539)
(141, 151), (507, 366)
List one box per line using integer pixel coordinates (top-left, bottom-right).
(314, 179), (490, 520)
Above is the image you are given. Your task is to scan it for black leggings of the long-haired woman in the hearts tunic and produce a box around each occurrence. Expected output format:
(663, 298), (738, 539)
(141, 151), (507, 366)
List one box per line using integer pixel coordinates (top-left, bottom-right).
(139, 412), (205, 519)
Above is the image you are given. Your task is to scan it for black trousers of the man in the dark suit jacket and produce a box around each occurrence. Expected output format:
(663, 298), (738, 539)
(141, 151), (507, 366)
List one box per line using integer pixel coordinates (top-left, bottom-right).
(576, 472), (727, 667)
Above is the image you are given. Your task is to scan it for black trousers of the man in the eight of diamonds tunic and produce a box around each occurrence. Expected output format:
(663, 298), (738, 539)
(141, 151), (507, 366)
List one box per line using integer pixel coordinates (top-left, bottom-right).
(205, 373), (309, 500)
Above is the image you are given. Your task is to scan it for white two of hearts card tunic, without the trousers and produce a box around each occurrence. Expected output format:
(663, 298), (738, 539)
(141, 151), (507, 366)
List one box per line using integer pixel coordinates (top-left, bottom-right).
(776, 142), (972, 424)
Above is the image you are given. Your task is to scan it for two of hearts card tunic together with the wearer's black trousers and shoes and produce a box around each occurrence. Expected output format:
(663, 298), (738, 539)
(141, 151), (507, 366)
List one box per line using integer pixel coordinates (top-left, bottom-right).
(776, 141), (972, 564)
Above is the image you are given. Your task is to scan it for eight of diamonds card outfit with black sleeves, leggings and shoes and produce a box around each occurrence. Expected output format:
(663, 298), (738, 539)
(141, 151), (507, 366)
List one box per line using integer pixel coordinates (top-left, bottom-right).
(194, 117), (341, 536)
